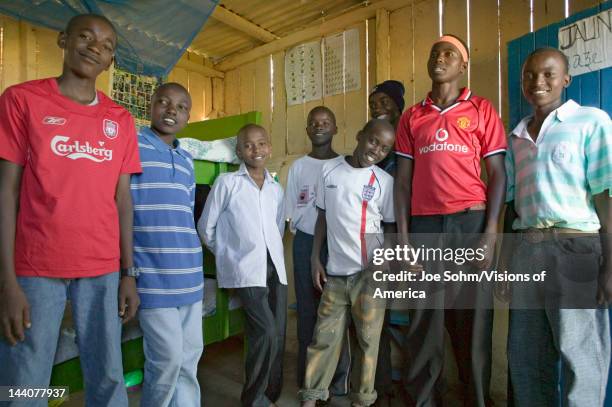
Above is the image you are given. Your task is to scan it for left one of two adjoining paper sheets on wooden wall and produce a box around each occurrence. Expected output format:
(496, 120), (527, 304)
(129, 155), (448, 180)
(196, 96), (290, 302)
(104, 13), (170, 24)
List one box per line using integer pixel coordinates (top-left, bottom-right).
(285, 41), (322, 106)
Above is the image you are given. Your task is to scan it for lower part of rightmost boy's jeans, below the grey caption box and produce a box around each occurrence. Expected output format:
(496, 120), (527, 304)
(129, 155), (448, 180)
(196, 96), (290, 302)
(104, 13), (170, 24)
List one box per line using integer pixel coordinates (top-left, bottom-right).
(508, 309), (610, 407)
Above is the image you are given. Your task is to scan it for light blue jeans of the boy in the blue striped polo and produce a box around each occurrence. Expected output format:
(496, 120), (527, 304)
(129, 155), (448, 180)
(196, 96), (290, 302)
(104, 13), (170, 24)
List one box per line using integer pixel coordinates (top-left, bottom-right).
(138, 301), (204, 407)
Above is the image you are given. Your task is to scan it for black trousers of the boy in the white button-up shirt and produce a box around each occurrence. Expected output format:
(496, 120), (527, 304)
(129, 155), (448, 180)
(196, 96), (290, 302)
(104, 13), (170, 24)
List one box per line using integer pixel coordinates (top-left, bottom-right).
(236, 256), (287, 407)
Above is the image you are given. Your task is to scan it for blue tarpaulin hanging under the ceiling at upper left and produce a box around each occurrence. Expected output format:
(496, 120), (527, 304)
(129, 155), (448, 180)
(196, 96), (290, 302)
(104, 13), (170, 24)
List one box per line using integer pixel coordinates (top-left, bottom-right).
(0, 0), (219, 77)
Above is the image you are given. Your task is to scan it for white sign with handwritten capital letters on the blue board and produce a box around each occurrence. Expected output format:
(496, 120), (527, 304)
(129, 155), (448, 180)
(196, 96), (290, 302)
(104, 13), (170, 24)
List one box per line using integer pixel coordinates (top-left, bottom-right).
(558, 9), (612, 76)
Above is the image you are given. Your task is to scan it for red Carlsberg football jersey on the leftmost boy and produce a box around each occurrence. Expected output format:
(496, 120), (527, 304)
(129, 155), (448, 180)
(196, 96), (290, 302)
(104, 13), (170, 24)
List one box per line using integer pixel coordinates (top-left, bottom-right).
(0, 78), (141, 278)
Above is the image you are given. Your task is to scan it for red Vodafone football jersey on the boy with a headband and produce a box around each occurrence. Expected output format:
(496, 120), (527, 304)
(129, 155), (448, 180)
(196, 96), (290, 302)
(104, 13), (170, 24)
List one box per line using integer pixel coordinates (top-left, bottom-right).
(395, 88), (507, 215)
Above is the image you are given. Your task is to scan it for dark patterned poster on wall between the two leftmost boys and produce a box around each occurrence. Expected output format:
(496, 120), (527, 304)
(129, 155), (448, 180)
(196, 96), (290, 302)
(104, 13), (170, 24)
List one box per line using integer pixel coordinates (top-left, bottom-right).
(111, 68), (160, 128)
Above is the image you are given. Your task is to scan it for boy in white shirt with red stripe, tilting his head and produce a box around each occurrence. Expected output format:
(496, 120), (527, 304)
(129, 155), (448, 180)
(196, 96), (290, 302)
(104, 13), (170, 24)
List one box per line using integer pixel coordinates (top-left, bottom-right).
(299, 119), (395, 407)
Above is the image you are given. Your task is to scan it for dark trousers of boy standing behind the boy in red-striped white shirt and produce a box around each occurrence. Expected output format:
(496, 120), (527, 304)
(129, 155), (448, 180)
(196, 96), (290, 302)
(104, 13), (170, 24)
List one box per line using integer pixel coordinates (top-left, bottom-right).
(293, 230), (351, 395)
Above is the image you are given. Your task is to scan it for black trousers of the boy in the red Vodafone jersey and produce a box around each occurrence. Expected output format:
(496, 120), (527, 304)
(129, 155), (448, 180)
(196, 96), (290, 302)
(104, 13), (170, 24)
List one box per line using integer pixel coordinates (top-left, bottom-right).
(403, 211), (493, 407)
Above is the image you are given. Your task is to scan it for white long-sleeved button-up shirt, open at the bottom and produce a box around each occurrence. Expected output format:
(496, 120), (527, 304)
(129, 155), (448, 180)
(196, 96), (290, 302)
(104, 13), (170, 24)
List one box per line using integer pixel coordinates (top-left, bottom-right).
(198, 164), (287, 288)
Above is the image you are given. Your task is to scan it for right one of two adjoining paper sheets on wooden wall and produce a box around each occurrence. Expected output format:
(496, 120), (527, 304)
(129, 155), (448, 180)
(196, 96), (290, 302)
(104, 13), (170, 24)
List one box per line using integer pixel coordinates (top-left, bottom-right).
(323, 28), (361, 96)
